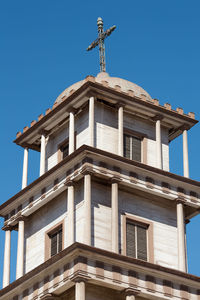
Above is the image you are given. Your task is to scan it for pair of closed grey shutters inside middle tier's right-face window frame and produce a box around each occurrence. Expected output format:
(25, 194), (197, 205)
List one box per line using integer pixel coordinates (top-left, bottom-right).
(126, 220), (147, 261)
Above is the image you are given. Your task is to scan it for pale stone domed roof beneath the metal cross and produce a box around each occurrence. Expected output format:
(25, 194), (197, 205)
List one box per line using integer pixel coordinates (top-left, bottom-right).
(55, 72), (152, 103)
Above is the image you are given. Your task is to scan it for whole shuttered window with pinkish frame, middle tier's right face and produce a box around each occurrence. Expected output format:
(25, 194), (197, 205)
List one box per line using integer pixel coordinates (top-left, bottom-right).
(122, 214), (154, 263)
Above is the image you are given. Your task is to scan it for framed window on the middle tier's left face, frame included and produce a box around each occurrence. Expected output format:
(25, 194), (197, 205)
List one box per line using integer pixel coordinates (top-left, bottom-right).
(45, 222), (64, 260)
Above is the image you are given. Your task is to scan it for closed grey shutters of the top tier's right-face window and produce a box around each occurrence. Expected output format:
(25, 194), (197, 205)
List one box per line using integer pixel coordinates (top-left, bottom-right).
(124, 134), (142, 162)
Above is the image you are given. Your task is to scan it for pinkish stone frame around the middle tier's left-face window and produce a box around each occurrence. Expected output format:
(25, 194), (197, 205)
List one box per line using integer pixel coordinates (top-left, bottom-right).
(44, 220), (65, 261)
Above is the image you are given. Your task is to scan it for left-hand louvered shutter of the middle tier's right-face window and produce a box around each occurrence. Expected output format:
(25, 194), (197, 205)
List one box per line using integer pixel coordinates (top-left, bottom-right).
(126, 223), (136, 258)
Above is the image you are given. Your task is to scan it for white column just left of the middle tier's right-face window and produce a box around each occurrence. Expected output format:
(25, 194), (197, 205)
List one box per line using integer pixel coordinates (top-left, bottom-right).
(111, 179), (119, 253)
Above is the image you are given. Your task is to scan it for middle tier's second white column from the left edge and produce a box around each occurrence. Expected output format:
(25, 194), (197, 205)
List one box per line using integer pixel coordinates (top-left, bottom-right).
(16, 220), (24, 279)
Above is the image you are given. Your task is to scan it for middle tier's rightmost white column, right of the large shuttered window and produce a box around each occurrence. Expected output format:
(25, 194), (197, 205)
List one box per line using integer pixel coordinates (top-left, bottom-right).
(177, 200), (186, 272)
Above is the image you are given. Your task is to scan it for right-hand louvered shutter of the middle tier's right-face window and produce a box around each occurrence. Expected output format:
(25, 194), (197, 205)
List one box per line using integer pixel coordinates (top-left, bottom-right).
(137, 225), (147, 261)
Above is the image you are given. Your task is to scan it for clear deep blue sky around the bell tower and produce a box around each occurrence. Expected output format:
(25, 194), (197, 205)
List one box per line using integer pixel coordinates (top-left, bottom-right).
(0, 0), (200, 286)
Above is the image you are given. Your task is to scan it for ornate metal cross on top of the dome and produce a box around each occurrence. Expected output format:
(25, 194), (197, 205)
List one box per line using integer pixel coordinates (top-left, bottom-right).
(87, 18), (116, 72)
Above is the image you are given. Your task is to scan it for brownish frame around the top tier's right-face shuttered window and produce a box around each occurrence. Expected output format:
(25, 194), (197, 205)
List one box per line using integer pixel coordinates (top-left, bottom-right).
(123, 128), (148, 164)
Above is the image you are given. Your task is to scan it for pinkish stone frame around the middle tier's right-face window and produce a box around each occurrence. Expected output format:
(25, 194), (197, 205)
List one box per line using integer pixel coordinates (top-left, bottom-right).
(122, 214), (154, 263)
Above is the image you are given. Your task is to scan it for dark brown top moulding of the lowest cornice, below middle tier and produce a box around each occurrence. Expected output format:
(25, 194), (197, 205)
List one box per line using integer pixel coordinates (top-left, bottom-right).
(0, 242), (200, 297)
